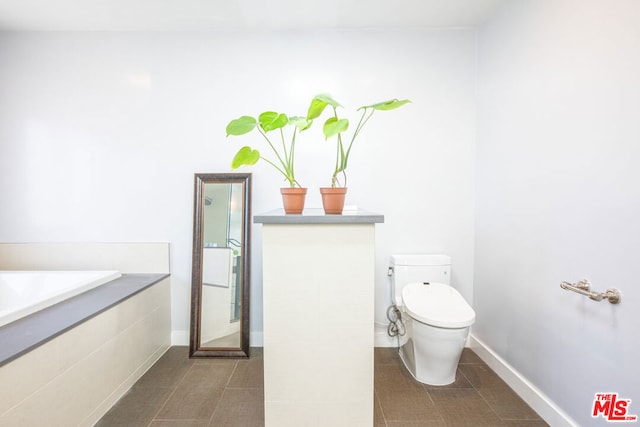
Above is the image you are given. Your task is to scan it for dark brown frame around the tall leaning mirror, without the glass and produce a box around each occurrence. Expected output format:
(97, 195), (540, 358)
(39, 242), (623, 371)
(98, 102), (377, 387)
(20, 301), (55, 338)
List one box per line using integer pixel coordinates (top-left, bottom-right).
(189, 173), (251, 358)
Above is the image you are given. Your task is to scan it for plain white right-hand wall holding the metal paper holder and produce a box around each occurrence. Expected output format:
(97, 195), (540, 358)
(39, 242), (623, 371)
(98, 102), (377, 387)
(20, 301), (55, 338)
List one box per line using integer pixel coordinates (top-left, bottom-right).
(473, 0), (640, 426)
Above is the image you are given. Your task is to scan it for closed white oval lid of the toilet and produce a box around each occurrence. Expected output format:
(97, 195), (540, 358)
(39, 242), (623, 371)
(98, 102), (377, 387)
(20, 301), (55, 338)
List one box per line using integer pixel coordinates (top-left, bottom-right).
(402, 282), (476, 328)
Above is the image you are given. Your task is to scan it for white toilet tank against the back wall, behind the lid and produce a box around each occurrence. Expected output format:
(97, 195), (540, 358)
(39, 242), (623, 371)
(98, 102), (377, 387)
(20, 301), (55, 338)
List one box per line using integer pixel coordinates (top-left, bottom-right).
(390, 255), (451, 306)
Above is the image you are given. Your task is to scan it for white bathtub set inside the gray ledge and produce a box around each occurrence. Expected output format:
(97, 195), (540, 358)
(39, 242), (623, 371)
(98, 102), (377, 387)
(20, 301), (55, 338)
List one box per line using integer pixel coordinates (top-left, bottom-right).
(0, 271), (121, 327)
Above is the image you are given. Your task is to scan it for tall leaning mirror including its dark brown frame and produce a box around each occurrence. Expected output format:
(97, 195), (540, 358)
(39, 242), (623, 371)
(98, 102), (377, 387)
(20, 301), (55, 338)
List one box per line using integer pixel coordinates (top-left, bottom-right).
(189, 173), (251, 357)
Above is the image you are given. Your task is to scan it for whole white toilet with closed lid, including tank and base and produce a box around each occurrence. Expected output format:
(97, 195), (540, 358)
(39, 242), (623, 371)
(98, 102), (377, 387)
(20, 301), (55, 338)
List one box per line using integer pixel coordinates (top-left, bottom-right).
(389, 255), (476, 385)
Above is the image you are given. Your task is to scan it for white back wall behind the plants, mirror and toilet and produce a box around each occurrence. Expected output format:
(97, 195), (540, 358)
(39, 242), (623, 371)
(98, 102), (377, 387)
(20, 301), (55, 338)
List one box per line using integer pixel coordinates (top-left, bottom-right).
(0, 30), (476, 343)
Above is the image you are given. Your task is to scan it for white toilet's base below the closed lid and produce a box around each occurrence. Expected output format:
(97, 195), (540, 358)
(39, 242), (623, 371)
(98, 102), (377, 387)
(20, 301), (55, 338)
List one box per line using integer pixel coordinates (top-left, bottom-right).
(398, 316), (469, 386)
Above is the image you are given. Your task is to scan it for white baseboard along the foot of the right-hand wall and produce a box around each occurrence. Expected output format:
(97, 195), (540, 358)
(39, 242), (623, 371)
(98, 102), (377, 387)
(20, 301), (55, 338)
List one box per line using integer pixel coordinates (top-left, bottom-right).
(469, 334), (578, 427)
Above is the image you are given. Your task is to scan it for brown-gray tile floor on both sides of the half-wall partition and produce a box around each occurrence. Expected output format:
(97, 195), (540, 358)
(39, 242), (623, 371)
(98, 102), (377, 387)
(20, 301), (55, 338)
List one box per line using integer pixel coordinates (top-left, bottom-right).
(97, 347), (547, 427)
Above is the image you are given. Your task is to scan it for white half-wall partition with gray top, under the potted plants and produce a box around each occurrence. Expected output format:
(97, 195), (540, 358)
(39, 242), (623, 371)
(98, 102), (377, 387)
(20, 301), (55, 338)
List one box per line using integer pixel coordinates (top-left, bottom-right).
(254, 209), (384, 427)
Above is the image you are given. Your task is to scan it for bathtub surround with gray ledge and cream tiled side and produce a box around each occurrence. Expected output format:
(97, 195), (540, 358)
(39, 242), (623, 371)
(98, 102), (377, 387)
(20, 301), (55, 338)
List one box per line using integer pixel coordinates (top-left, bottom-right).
(0, 274), (171, 426)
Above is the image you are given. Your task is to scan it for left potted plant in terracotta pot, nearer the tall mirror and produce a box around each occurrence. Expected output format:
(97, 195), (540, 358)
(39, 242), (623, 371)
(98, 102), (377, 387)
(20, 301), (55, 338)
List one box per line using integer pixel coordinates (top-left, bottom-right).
(227, 111), (312, 214)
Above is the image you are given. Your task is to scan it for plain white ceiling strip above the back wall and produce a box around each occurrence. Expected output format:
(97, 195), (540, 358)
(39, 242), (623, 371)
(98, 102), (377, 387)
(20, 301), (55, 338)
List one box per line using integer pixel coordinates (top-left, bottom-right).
(0, 0), (504, 31)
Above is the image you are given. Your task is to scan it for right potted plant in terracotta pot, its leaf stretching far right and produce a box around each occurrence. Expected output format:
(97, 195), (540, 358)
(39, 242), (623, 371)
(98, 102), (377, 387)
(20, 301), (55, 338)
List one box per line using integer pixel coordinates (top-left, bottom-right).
(307, 94), (411, 214)
